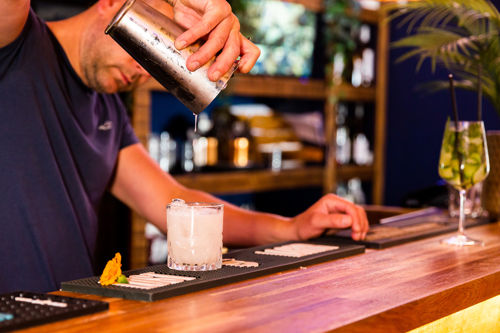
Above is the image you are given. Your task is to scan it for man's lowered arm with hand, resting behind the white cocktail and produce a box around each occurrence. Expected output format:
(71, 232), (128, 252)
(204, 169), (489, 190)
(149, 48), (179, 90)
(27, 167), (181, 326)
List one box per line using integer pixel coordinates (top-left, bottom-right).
(111, 144), (368, 245)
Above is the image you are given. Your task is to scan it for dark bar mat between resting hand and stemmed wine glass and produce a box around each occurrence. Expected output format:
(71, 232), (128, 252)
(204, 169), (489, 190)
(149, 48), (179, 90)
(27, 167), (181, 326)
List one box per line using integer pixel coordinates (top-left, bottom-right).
(335, 208), (491, 249)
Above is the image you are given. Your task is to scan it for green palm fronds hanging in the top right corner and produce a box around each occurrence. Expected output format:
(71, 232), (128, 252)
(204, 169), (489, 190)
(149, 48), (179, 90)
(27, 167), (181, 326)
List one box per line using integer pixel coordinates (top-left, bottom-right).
(386, 0), (500, 116)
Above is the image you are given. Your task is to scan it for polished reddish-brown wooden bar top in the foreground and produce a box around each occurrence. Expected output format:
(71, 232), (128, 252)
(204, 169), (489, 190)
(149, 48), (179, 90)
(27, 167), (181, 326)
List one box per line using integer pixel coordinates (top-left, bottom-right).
(19, 222), (500, 332)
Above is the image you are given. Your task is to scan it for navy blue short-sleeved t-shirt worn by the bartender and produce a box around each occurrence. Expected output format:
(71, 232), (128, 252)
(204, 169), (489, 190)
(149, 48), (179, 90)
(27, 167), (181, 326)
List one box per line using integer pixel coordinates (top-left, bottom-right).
(0, 11), (138, 293)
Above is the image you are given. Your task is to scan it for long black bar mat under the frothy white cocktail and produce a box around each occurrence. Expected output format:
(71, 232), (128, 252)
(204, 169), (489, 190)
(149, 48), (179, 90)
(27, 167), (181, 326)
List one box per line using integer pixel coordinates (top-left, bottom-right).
(61, 239), (365, 302)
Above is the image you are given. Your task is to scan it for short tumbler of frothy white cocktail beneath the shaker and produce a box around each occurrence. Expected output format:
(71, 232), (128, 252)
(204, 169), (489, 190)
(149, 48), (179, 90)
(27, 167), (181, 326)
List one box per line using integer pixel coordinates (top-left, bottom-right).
(167, 199), (224, 271)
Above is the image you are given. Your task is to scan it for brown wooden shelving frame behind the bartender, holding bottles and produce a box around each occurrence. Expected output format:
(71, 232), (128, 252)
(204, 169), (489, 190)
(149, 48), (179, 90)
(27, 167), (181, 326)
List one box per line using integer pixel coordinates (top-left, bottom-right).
(127, 0), (389, 268)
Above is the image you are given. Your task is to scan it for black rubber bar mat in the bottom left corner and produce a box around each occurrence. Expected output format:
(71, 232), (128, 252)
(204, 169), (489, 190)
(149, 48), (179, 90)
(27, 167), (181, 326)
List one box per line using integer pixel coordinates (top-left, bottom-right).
(0, 291), (109, 332)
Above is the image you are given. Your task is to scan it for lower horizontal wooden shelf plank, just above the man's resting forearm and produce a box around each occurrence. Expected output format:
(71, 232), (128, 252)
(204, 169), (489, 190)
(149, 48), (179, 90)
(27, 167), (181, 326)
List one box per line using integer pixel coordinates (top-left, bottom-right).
(174, 165), (373, 194)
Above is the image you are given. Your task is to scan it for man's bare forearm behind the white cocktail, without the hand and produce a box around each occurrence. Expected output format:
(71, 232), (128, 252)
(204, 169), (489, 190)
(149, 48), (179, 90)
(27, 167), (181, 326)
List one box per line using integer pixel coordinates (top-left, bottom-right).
(111, 144), (297, 245)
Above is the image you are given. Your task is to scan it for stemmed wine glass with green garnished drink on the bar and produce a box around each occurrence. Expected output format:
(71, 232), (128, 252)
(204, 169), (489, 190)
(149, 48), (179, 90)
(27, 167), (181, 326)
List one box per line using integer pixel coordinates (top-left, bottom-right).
(439, 119), (490, 246)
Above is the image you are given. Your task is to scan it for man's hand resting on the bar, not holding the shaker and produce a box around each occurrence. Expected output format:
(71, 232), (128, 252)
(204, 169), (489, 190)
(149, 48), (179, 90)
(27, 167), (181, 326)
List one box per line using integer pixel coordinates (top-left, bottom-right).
(292, 194), (369, 240)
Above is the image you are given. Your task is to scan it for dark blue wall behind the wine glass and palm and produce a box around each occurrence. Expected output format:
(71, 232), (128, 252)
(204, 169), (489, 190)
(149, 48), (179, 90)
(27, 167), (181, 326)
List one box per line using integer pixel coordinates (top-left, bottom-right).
(385, 13), (500, 205)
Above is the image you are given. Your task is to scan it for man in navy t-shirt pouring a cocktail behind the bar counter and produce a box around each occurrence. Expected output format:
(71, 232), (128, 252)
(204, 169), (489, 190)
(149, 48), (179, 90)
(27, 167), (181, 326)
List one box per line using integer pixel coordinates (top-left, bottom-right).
(0, 0), (368, 292)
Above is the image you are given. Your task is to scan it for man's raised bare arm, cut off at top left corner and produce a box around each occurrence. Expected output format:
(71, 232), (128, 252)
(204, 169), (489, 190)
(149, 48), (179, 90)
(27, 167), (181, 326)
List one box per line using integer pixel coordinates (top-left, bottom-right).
(0, 0), (30, 47)
